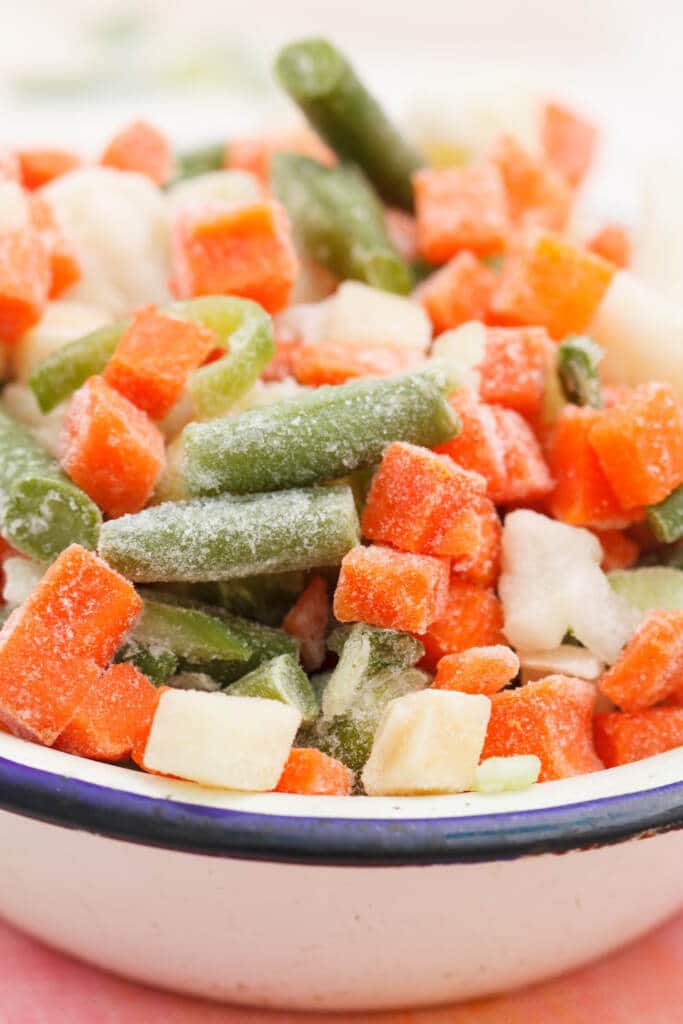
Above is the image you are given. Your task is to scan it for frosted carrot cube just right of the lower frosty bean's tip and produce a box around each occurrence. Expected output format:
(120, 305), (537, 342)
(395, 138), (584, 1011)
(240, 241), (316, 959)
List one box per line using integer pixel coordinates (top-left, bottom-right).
(334, 545), (449, 633)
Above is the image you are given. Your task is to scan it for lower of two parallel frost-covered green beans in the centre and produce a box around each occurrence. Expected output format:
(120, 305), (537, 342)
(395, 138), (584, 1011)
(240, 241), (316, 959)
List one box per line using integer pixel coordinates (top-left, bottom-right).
(99, 487), (358, 583)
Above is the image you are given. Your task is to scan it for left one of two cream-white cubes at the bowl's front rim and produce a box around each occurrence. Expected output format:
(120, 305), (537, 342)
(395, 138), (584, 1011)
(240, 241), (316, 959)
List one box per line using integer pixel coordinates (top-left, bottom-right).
(144, 690), (301, 793)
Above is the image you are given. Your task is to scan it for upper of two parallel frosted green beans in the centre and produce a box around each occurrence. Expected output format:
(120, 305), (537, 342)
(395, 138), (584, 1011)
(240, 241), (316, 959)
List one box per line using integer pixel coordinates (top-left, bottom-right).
(183, 374), (459, 495)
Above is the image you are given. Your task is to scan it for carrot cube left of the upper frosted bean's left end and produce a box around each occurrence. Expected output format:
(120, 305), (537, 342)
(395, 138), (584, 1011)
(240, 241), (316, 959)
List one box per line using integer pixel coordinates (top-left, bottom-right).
(61, 377), (165, 516)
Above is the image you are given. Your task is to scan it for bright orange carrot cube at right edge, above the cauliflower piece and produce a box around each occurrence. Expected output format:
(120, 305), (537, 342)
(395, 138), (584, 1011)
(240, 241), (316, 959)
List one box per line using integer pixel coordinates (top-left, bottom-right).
(589, 381), (683, 509)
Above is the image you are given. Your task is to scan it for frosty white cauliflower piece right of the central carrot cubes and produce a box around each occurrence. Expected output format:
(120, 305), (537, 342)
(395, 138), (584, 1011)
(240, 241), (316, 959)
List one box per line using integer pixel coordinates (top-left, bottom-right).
(499, 509), (637, 665)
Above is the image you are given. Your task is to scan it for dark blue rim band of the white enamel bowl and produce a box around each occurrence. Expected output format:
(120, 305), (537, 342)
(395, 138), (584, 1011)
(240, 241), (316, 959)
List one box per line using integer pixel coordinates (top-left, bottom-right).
(0, 758), (683, 866)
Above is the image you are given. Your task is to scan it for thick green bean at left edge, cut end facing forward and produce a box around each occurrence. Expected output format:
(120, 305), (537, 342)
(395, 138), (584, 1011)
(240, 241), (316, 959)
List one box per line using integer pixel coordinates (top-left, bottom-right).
(0, 410), (101, 562)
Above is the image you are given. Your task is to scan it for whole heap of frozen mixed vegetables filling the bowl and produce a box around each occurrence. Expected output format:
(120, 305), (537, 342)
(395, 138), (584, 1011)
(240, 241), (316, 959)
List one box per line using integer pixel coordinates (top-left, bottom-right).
(0, 39), (683, 796)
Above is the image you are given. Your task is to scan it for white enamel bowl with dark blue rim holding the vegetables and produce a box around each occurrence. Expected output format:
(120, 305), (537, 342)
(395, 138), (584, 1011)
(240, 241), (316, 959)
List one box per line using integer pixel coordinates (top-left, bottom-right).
(0, 734), (683, 1011)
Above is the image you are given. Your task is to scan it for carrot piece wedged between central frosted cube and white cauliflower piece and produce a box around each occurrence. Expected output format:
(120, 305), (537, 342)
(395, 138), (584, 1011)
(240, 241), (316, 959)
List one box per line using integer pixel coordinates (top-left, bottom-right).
(420, 580), (505, 669)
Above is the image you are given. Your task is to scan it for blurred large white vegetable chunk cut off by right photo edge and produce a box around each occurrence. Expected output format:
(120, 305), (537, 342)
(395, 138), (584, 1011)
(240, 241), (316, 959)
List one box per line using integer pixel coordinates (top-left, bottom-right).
(589, 270), (683, 400)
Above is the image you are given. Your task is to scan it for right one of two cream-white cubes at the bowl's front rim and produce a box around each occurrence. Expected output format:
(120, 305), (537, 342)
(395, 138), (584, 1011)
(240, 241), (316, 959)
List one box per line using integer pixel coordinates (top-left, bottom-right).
(362, 689), (490, 796)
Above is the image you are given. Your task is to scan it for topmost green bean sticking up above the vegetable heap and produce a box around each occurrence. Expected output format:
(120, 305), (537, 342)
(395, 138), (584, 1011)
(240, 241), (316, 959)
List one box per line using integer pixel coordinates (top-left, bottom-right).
(275, 39), (424, 210)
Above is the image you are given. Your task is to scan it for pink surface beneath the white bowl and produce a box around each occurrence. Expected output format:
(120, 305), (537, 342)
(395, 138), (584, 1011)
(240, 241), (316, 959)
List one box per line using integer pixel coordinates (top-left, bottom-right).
(0, 913), (683, 1024)
